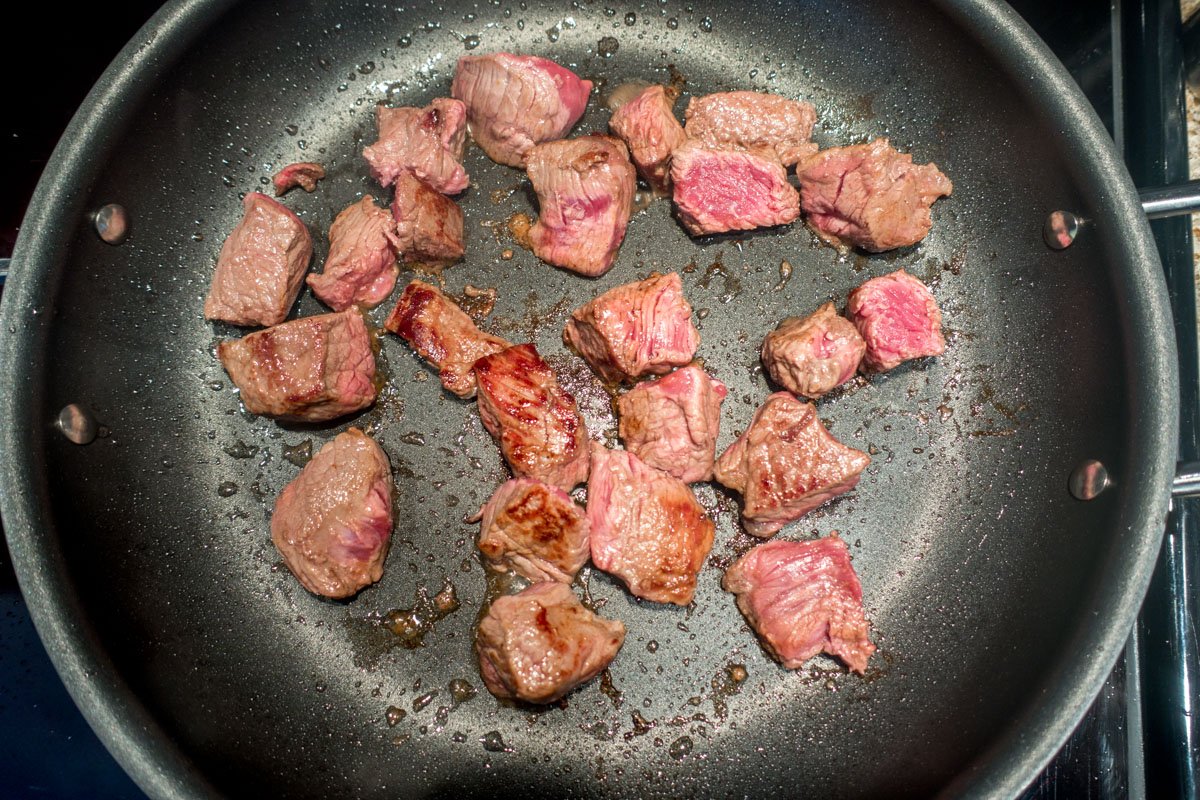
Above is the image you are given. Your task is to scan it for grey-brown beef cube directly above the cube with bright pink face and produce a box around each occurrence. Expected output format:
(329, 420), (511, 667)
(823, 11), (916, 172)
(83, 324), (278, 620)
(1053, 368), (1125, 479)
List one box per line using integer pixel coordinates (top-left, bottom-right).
(685, 91), (817, 167)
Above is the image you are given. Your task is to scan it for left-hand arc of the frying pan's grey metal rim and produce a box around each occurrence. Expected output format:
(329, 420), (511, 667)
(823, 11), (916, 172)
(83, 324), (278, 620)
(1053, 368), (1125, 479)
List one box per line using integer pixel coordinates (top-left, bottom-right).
(0, 0), (236, 798)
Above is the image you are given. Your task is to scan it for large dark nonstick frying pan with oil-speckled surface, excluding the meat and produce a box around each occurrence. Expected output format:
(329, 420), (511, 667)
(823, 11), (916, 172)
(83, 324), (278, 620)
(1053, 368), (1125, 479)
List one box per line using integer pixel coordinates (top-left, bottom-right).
(0, 0), (1177, 798)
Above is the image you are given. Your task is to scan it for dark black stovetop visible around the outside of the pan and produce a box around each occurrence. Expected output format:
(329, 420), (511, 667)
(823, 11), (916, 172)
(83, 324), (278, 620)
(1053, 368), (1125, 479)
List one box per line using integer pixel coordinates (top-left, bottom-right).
(0, 0), (1200, 800)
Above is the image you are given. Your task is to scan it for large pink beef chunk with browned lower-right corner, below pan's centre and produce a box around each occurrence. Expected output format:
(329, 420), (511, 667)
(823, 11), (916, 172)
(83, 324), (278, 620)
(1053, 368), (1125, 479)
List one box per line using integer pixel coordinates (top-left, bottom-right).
(588, 444), (714, 606)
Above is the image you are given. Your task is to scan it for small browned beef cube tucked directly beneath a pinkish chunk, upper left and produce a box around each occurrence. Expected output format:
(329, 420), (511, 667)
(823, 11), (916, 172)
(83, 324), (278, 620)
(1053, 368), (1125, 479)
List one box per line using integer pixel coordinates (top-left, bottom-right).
(391, 173), (463, 264)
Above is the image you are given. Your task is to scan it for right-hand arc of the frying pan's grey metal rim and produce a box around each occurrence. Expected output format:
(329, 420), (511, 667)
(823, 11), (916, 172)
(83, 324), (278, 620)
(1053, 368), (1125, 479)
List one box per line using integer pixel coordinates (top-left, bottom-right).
(937, 0), (1180, 796)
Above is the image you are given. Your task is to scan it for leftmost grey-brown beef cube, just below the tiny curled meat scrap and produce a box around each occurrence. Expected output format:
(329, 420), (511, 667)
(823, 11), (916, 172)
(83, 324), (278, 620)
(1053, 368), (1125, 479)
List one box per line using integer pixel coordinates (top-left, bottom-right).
(204, 192), (312, 325)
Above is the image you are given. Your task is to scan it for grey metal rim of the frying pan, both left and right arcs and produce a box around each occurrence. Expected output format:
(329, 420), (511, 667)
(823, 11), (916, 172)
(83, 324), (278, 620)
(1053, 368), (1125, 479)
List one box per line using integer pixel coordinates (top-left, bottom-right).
(0, 0), (1178, 798)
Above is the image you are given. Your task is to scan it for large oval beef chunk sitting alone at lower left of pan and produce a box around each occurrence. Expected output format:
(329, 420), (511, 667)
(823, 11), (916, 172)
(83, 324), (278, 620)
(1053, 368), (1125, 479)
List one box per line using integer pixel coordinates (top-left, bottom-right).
(271, 428), (392, 599)
